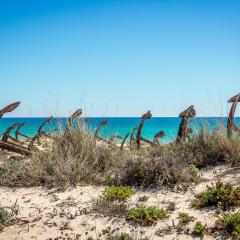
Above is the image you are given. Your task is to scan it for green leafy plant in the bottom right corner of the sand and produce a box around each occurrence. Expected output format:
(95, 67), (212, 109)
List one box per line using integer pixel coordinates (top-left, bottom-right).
(215, 212), (240, 237)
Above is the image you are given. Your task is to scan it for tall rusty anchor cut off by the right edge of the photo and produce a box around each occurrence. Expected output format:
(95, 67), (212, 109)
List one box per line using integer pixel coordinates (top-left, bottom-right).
(227, 93), (240, 140)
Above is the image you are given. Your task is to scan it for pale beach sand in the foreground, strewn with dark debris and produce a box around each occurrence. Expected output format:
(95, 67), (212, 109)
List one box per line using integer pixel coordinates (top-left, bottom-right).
(0, 167), (240, 240)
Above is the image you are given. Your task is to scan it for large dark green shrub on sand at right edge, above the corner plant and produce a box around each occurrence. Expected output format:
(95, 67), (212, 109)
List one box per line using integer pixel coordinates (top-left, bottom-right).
(192, 182), (240, 210)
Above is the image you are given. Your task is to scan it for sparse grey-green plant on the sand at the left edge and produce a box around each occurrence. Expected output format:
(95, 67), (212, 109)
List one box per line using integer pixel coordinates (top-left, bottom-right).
(0, 201), (18, 232)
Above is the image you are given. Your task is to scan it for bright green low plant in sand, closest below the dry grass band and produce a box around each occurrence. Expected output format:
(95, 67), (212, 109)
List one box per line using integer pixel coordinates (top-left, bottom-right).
(103, 186), (135, 201)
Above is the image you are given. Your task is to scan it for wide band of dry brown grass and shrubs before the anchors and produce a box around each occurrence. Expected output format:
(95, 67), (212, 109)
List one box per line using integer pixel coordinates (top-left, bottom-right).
(0, 124), (240, 191)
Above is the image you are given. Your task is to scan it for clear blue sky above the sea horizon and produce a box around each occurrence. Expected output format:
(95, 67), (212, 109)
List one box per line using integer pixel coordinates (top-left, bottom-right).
(0, 0), (240, 116)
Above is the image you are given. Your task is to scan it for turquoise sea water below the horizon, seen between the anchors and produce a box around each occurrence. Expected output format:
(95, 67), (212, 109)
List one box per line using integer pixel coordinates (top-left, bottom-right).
(0, 117), (240, 143)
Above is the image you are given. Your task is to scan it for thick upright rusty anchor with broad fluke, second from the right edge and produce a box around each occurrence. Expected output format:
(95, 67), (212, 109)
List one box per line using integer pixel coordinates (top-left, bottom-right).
(176, 105), (196, 143)
